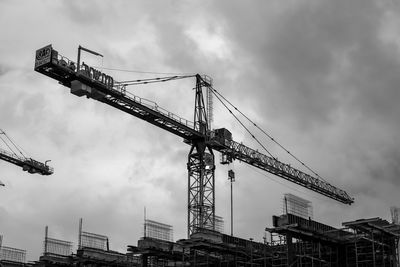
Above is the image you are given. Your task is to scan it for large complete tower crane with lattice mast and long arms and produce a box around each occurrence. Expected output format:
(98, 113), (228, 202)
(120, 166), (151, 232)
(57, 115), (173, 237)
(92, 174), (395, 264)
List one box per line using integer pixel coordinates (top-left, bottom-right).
(34, 45), (354, 239)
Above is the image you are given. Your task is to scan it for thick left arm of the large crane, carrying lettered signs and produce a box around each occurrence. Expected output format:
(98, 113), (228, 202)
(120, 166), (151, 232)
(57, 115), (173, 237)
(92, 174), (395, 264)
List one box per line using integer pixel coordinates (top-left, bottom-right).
(35, 45), (205, 142)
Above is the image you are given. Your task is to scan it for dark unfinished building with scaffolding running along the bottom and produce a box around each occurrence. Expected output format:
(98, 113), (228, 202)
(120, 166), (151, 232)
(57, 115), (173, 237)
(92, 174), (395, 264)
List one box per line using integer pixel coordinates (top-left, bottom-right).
(0, 213), (400, 267)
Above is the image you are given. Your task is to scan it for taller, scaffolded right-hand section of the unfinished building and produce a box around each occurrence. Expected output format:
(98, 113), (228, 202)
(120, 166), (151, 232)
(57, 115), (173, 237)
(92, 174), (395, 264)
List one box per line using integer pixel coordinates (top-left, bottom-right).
(266, 214), (400, 267)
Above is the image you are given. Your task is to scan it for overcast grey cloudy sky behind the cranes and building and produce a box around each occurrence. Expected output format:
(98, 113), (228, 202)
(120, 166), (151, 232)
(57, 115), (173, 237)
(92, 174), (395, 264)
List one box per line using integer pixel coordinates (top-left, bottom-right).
(0, 0), (400, 260)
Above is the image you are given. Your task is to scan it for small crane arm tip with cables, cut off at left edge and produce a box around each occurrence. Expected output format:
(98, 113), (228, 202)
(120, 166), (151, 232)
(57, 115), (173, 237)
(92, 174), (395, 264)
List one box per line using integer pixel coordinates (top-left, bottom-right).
(0, 129), (54, 175)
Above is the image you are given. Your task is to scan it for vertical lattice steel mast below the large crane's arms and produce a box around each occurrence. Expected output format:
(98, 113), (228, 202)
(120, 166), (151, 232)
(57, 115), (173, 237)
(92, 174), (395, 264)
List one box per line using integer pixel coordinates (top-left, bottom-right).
(187, 142), (215, 238)
